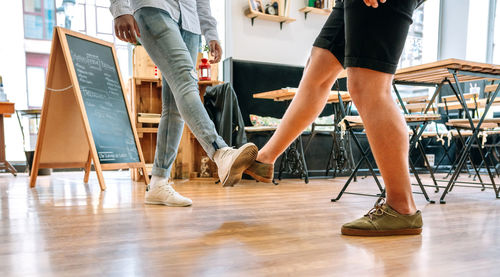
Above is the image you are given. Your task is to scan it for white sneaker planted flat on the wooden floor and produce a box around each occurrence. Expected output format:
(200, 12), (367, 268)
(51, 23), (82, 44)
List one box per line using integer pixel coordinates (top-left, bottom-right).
(144, 179), (193, 207)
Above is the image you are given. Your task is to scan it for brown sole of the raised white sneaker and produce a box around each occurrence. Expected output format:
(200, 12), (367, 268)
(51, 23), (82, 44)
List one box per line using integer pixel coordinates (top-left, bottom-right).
(222, 144), (258, 187)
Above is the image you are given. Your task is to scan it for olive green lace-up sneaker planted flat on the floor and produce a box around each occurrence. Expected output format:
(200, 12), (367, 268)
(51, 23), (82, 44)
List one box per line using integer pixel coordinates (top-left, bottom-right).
(341, 198), (423, 236)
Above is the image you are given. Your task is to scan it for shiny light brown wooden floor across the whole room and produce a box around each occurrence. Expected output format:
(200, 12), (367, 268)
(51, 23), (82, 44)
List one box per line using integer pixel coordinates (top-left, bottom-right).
(0, 172), (500, 276)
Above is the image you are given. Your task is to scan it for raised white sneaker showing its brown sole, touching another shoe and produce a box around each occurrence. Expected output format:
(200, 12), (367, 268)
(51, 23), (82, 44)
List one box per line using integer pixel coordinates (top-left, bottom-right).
(214, 143), (258, 187)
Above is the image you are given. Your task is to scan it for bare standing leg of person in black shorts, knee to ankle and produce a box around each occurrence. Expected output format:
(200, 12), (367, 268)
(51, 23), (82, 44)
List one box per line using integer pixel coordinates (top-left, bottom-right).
(347, 68), (416, 214)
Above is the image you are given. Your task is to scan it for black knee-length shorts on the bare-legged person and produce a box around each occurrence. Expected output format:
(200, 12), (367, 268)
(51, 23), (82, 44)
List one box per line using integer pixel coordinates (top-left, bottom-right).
(314, 0), (421, 74)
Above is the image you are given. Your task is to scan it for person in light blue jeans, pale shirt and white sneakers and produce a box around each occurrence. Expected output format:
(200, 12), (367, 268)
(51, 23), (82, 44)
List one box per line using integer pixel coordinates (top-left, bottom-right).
(110, 0), (257, 206)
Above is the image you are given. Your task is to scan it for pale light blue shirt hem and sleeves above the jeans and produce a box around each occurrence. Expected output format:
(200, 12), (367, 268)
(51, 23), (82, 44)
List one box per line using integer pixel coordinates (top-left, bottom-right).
(109, 0), (219, 42)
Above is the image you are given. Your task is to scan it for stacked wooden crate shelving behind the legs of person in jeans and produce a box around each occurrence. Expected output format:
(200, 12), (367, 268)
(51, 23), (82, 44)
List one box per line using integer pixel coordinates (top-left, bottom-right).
(127, 46), (220, 180)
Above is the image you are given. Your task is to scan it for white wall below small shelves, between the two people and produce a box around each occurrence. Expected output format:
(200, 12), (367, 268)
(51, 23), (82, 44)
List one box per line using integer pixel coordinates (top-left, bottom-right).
(226, 0), (327, 66)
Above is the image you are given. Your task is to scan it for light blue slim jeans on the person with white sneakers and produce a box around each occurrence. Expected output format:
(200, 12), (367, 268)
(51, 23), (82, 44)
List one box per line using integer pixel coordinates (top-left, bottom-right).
(134, 8), (227, 177)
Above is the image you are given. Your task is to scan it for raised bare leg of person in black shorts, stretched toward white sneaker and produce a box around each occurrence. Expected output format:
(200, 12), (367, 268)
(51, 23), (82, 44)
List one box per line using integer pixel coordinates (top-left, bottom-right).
(257, 47), (343, 164)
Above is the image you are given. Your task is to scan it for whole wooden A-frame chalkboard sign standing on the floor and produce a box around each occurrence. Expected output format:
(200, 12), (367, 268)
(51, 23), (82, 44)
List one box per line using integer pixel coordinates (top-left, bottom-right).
(30, 27), (149, 190)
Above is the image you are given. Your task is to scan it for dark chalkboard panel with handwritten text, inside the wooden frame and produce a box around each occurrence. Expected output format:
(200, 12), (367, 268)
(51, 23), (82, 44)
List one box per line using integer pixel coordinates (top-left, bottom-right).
(66, 34), (140, 164)
